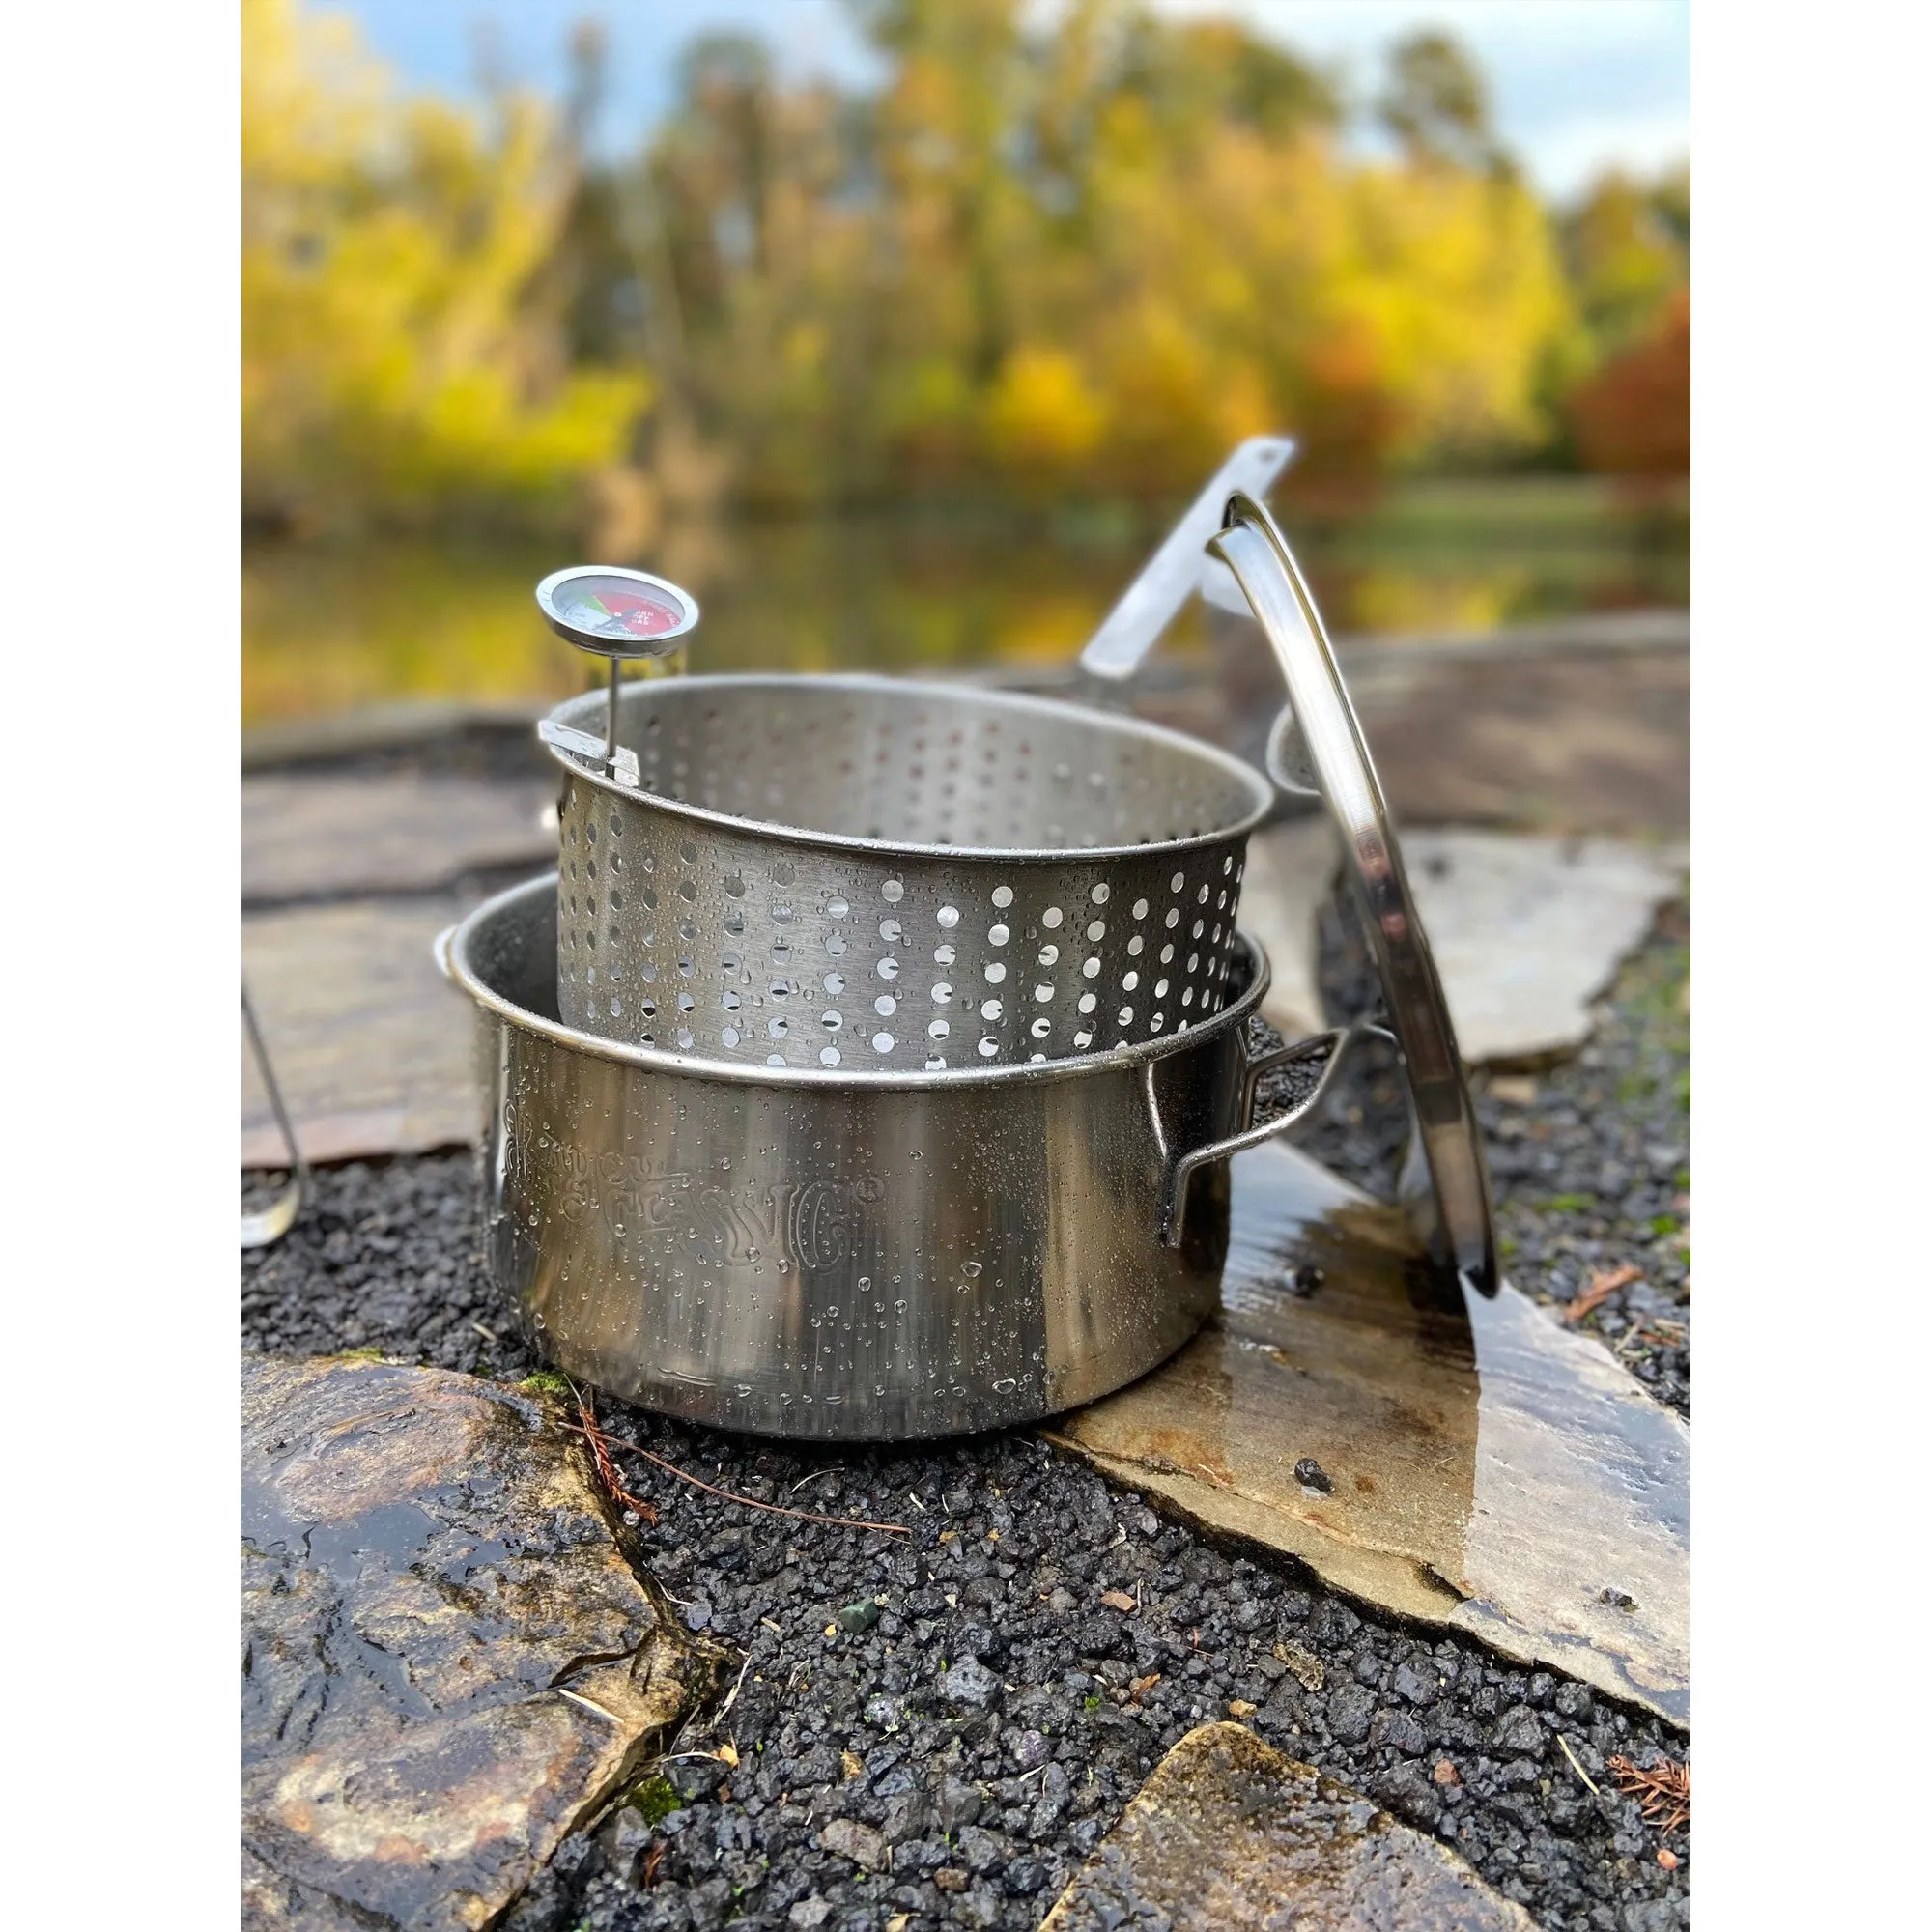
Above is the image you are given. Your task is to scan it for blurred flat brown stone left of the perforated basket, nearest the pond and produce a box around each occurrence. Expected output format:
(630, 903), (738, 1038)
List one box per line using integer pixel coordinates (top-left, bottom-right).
(242, 773), (556, 902)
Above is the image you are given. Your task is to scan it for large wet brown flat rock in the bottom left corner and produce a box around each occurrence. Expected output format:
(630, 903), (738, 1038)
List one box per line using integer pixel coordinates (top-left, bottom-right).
(242, 1356), (703, 1932)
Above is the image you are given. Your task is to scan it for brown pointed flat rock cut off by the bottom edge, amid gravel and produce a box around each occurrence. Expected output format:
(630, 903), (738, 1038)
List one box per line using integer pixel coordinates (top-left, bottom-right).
(1041, 1723), (1536, 1932)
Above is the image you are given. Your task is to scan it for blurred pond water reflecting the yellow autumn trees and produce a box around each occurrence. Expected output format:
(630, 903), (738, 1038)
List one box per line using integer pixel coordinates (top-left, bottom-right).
(242, 479), (1689, 721)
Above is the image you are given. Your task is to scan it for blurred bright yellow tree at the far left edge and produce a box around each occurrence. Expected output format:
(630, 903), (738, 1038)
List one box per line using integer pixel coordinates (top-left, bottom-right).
(242, 0), (649, 529)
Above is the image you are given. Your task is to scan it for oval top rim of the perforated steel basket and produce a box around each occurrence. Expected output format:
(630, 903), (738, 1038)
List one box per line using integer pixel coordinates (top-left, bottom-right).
(545, 670), (1275, 866)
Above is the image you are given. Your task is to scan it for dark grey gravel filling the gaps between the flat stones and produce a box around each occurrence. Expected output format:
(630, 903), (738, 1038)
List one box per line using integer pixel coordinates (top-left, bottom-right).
(242, 914), (1690, 1932)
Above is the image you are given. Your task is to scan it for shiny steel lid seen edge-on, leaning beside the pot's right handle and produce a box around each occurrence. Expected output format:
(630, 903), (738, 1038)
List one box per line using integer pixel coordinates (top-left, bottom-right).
(1208, 493), (1497, 1294)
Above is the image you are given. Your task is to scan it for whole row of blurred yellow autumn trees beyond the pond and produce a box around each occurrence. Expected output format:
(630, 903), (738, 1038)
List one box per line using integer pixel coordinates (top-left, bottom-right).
(243, 0), (1689, 527)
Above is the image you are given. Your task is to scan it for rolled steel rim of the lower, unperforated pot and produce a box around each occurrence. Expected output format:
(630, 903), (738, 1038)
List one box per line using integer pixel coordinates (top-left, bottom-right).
(437, 871), (1271, 1092)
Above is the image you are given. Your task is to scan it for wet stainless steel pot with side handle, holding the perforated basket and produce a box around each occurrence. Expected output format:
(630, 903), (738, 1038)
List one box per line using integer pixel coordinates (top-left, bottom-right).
(440, 875), (1333, 1439)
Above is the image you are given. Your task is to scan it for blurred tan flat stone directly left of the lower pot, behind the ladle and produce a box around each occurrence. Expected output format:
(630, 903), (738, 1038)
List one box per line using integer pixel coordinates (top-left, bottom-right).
(242, 898), (477, 1167)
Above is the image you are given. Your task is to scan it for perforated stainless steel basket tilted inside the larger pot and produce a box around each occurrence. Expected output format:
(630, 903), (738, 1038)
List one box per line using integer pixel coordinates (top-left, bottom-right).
(551, 676), (1273, 1070)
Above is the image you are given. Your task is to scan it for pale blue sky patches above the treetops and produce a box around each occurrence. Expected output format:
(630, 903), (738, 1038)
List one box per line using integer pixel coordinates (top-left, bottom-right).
(332, 0), (1690, 199)
